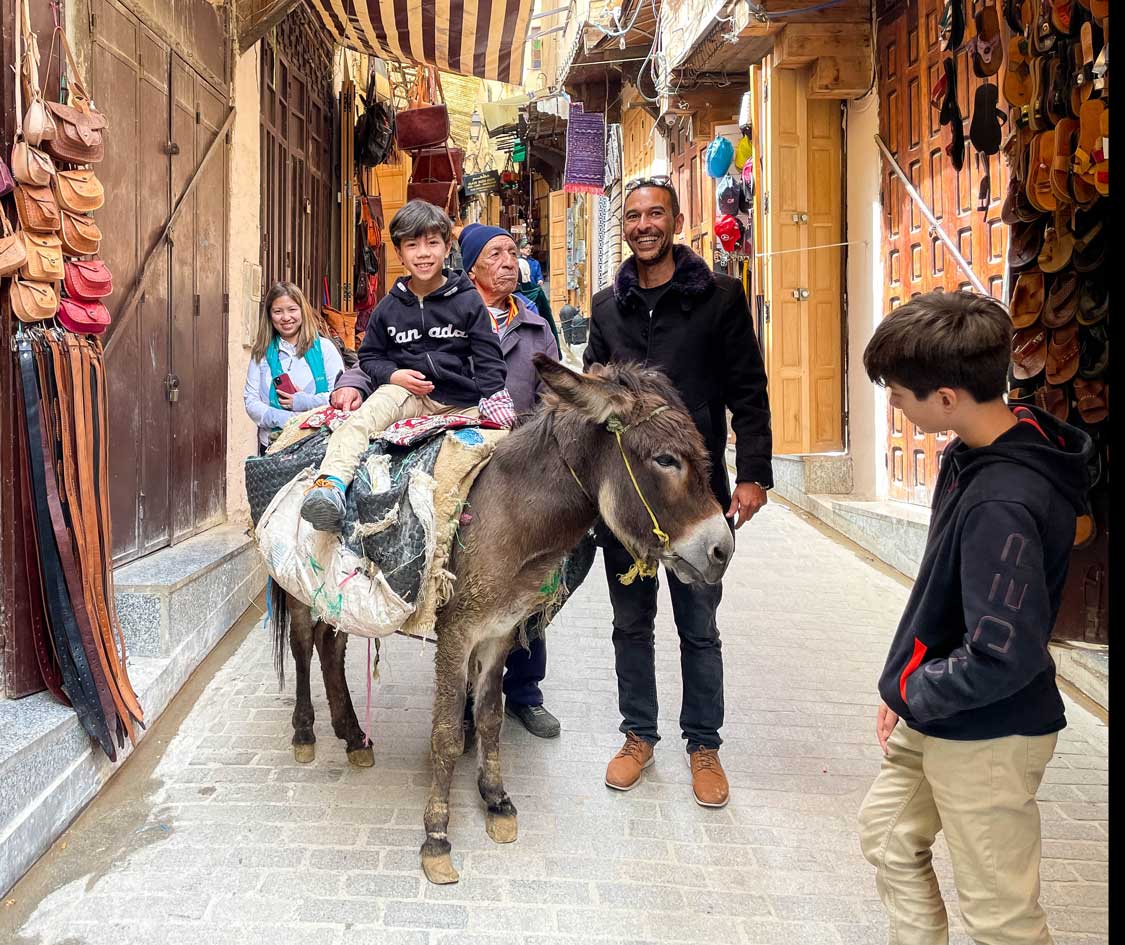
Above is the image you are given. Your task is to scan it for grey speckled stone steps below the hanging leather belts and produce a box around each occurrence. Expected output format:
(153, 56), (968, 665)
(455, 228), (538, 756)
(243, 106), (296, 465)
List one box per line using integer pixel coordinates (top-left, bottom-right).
(0, 525), (266, 896)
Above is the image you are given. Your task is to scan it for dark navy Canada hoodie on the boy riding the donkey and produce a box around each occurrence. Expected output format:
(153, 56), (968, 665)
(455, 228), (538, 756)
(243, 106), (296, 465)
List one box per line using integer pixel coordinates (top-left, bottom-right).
(359, 269), (507, 407)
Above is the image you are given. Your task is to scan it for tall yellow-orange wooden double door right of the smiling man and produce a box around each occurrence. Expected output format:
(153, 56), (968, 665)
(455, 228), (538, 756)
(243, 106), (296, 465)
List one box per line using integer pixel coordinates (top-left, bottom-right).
(761, 69), (844, 455)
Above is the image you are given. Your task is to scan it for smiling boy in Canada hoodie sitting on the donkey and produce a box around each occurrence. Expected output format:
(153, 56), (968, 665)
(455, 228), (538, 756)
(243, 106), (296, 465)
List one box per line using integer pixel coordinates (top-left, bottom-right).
(300, 200), (515, 531)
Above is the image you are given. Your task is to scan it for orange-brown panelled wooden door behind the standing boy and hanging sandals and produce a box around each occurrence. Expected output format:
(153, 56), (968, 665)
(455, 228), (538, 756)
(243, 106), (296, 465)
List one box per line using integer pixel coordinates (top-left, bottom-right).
(878, 0), (1008, 505)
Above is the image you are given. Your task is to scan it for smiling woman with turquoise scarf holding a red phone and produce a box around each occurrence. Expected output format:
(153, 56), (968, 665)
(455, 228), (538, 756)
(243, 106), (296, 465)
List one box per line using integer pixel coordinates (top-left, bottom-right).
(242, 282), (344, 456)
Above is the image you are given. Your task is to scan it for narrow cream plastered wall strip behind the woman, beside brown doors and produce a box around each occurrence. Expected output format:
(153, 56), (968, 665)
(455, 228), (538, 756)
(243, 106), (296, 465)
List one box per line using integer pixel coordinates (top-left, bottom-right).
(226, 43), (262, 525)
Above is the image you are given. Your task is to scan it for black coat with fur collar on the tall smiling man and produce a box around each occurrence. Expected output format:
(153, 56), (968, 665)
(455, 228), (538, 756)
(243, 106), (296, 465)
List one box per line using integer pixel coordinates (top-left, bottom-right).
(583, 245), (773, 512)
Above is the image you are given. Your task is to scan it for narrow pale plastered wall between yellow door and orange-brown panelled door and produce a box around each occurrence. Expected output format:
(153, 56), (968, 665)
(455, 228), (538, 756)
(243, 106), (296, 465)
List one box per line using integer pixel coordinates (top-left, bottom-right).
(846, 91), (887, 498)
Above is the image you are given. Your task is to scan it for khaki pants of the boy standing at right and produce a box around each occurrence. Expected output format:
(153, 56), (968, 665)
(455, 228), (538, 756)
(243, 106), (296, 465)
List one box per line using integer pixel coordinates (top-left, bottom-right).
(860, 722), (1058, 945)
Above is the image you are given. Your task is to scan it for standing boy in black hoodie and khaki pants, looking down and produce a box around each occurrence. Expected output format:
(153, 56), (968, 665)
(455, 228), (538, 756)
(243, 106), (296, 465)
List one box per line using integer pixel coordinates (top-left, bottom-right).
(860, 291), (1092, 945)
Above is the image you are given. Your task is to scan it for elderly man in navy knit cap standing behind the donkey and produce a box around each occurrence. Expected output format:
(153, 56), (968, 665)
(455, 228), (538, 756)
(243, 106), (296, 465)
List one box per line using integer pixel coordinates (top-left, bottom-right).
(332, 223), (571, 745)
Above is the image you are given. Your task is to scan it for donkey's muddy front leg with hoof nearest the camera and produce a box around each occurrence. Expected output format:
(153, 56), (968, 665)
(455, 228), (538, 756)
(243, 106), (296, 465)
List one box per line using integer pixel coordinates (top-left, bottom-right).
(422, 627), (469, 884)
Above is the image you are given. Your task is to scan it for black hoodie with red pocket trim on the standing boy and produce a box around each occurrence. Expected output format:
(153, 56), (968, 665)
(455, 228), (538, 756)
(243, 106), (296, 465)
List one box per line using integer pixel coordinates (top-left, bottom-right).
(879, 407), (1094, 740)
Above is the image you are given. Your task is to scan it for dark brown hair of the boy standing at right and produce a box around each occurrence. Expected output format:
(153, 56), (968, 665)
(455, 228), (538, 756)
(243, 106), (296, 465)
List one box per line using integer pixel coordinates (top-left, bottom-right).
(863, 290), (1011, 404)
